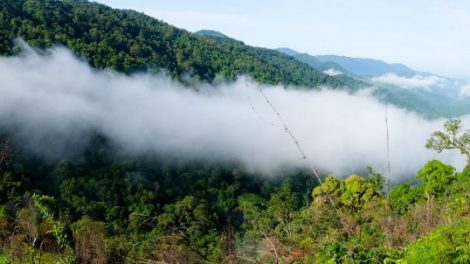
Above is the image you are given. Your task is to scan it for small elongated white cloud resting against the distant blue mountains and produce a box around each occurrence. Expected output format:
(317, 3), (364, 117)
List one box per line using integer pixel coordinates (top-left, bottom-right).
(372, 73), (445, 89)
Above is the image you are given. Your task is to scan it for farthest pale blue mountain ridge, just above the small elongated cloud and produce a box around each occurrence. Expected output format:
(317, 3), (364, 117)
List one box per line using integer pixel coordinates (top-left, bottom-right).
(315, 55), (417, 77)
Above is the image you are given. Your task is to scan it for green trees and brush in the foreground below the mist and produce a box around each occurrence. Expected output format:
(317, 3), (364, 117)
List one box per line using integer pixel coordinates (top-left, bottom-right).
(0, 113), (470, 263)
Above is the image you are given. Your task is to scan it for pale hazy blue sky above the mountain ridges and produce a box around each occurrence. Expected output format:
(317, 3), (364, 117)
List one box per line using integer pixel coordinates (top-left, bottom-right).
(93, 0), (470, 79)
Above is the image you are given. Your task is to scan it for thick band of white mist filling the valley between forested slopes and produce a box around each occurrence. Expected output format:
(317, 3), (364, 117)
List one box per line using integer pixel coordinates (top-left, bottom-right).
(0, 46), (470, 180)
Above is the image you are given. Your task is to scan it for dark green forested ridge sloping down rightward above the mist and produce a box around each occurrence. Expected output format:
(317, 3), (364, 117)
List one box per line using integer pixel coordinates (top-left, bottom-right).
(0, 0), (361, 87)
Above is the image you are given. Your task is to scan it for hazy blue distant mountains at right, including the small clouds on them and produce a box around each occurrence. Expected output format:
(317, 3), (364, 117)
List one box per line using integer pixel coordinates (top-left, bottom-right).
(277, 48), (470, 118)
